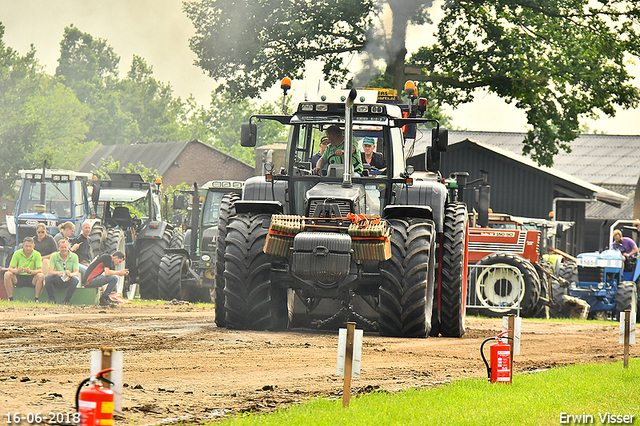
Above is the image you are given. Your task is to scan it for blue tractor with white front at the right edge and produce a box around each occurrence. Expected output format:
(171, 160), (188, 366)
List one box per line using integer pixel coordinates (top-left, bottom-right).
(570, 250), (640, 319)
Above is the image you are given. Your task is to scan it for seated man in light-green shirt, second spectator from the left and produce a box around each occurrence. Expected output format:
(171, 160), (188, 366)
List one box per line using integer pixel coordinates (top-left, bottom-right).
(44, 239), (80, 305)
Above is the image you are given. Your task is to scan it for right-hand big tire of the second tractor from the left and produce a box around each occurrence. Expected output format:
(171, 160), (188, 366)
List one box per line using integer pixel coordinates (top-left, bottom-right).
(136, 230), (171, 299)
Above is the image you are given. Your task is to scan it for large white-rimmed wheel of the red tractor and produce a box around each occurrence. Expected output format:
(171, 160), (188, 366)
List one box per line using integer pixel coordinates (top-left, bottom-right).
(474, 252), (540, 317)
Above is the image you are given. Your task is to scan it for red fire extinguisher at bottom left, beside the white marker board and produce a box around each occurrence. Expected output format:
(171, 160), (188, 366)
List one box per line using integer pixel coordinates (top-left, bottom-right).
(76, 368), (113, 426)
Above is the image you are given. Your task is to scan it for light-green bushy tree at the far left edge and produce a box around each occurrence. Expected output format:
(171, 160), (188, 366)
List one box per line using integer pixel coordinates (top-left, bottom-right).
(0, 24), (91, 195)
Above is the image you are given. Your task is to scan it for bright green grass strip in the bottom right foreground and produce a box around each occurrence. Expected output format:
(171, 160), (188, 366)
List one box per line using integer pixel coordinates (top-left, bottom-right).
(216, 359), (640, 426)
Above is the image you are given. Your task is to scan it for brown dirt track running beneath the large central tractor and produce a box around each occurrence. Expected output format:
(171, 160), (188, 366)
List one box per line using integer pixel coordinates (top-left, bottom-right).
(0, 305), (640, 424)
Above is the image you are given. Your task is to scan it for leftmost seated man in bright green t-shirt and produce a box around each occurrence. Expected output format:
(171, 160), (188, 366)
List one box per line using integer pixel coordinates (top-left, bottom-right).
(4, 237), (44, 302)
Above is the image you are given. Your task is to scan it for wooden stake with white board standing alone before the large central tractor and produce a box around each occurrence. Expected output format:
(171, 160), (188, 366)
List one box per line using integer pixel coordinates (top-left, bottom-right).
(336, 322), (363, 407)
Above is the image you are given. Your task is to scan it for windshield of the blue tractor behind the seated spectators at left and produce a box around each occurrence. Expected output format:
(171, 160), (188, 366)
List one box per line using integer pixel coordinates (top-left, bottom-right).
(17, 179), (73, 219)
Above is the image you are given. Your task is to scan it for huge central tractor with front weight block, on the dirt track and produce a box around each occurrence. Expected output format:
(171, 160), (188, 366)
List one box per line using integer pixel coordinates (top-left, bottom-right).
(216, 82), (468, 337)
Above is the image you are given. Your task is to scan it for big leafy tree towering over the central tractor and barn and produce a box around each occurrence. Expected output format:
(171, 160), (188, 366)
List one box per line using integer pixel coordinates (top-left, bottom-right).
(185, 0), (640, 165)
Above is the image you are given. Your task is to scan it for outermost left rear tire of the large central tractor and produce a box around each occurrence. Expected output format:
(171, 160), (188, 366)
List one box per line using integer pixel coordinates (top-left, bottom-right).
(214, 194), (240, 327)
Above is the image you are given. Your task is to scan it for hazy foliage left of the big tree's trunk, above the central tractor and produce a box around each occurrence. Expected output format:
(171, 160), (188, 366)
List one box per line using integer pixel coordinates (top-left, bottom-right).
(184, 0), (379, 99)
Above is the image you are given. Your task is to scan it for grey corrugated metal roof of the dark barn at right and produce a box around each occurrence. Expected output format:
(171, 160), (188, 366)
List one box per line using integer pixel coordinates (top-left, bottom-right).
(442, 130), (640, 185)
